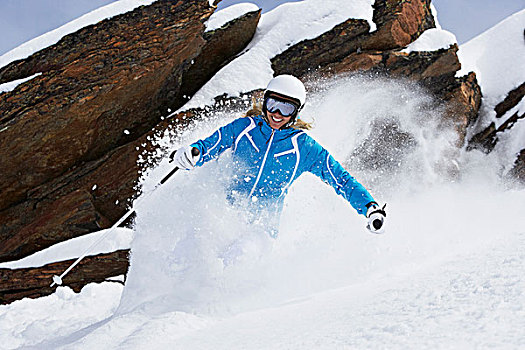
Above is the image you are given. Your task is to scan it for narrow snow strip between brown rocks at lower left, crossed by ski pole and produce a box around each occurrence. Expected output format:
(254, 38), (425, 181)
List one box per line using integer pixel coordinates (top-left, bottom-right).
(0, 227), (133, 269)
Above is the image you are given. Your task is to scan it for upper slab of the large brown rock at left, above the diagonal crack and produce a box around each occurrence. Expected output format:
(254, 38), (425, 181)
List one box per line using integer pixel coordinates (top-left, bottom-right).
(0, 0), (259, 210)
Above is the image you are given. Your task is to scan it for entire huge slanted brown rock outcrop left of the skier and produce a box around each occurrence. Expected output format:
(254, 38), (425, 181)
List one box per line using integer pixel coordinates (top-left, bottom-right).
(0, 1), (260, 261)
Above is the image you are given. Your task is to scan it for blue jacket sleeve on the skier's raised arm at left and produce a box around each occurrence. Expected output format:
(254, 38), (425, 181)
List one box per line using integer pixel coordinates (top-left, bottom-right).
(191, 118), (250, 166)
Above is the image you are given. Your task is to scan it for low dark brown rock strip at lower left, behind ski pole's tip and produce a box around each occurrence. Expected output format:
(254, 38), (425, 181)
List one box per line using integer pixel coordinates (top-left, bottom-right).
(0, 250), (129, 305)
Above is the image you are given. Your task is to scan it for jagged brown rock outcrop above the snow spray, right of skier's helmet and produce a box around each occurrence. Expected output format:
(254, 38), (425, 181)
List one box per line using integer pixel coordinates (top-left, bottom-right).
(272, 0), (481, 146)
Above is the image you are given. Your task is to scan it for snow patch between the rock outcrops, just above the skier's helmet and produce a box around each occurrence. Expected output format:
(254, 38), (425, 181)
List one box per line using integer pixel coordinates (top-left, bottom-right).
(180, 0), (375, 110)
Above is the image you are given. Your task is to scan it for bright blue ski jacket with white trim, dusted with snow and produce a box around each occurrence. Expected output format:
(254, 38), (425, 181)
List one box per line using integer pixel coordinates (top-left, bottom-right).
(191, 116), (374, 215)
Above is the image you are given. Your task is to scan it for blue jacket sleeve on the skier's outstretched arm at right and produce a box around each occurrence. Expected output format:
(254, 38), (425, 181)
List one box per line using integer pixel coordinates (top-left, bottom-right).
(305, 136), (375, 215)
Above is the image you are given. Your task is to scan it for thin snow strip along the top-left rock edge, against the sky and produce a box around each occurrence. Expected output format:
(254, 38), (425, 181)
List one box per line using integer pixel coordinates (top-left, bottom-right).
(0, 0), (157, 68)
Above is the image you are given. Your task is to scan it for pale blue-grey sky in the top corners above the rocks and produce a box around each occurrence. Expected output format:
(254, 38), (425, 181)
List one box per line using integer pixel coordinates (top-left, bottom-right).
(0, 0), (525, 55)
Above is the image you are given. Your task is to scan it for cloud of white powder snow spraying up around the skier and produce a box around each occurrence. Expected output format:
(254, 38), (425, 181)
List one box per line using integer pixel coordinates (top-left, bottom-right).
(118, 76), (511, 314)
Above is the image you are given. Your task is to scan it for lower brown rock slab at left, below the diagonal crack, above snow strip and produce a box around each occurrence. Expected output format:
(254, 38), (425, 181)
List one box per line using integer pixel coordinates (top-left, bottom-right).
(0, 93), (258, 261)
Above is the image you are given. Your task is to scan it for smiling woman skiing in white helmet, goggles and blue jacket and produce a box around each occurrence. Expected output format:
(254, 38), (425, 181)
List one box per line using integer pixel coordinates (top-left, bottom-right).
(170, 75), (386, 236)
